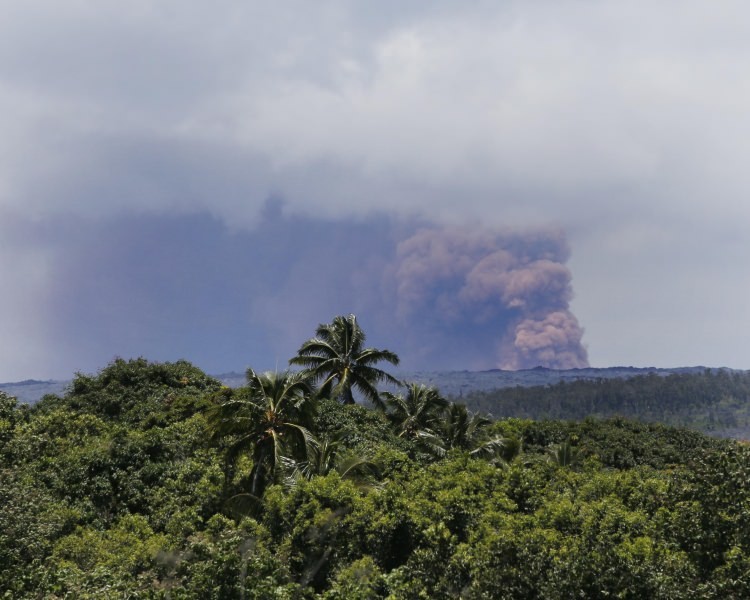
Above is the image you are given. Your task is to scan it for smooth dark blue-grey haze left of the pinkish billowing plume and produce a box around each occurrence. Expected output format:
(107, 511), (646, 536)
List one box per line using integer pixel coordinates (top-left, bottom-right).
(14, 203), (398, 376)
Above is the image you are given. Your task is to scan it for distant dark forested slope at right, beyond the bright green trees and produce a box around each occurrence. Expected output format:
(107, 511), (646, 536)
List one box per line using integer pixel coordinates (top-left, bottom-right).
(460, 369), (750, 438)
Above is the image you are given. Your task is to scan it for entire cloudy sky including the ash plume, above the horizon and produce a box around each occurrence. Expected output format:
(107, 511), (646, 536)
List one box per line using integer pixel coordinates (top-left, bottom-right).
(0, 0), (750, 381)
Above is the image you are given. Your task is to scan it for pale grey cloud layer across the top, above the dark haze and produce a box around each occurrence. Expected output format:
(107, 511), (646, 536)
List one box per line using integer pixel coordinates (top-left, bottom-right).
(0, 1), (750, 227)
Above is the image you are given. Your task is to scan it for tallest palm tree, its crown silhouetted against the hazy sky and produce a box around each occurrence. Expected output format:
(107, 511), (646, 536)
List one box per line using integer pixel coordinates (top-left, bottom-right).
(289, 315), (400, 406)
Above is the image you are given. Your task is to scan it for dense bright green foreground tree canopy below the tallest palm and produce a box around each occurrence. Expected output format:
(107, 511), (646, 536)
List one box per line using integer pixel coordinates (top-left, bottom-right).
(0, 326), (750, 600)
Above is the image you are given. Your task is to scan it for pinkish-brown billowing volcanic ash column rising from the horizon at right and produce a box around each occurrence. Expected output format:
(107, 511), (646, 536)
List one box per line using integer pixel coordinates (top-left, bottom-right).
(391, 228), (588, 369)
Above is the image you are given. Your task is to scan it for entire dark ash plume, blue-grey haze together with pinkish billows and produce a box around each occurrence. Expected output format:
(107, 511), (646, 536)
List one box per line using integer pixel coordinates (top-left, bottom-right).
(0, 205), (585, 376)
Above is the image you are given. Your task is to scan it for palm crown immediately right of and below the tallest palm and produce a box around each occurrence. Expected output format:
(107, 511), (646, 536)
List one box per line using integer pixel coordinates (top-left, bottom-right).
(383, 383), (448, 446)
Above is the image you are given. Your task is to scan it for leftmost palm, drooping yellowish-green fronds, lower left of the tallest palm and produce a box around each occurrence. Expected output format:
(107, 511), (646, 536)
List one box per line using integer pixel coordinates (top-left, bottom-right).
(208, 369), (314, 498)
